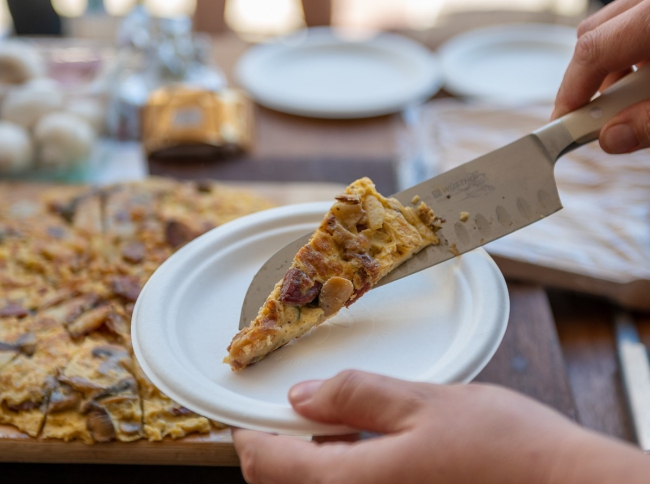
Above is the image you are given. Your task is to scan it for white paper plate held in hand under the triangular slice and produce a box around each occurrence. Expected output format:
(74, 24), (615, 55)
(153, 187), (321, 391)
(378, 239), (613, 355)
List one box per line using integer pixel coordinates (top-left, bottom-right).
(132, 202), (509, 435)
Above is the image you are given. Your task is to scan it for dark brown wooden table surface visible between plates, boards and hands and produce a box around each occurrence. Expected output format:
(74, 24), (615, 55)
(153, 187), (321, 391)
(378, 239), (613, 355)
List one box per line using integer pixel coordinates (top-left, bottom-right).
(0, 13), (650, 484)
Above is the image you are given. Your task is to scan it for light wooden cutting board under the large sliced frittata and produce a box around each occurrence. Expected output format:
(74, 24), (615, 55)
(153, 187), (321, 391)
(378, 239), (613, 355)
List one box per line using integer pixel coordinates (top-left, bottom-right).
(0, 182), (345, 466)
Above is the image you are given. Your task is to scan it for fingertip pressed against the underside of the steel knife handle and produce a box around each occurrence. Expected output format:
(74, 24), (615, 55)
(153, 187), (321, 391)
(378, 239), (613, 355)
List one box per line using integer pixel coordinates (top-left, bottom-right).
(600, 101), (650, 154)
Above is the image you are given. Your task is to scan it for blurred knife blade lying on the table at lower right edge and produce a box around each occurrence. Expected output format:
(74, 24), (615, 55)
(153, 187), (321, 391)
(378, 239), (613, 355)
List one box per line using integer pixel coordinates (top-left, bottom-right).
(615, 312), (650, 454)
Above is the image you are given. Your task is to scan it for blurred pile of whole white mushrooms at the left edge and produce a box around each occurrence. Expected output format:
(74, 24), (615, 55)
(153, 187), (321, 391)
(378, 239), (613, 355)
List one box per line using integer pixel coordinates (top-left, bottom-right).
(0, 40), (111, 181)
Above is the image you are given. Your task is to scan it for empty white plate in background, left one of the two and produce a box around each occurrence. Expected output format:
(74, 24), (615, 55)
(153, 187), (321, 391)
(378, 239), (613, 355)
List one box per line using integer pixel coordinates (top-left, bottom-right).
(237, 27), (442, 118)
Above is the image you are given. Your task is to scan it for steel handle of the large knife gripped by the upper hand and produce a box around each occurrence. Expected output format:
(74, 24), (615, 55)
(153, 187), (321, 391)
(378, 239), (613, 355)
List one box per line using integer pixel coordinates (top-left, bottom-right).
(560, 62), (650, 145)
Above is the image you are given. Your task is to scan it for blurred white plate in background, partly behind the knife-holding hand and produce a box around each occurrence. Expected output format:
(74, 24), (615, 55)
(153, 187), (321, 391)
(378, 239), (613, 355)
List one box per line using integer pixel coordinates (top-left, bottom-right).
(439, 24), (576, 103)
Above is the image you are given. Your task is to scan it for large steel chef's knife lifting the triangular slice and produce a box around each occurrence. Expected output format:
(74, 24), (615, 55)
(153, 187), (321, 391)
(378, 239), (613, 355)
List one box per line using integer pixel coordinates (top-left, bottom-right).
(239, 64), (650, 329)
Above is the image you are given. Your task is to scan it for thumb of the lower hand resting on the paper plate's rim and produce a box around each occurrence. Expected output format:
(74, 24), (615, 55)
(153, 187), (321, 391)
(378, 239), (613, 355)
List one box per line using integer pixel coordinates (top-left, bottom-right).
(289, 370), (428, 433)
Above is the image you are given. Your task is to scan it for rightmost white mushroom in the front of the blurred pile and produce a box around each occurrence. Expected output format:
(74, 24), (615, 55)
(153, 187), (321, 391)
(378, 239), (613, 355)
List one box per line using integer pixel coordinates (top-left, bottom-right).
(34, 112), (95, 168)
